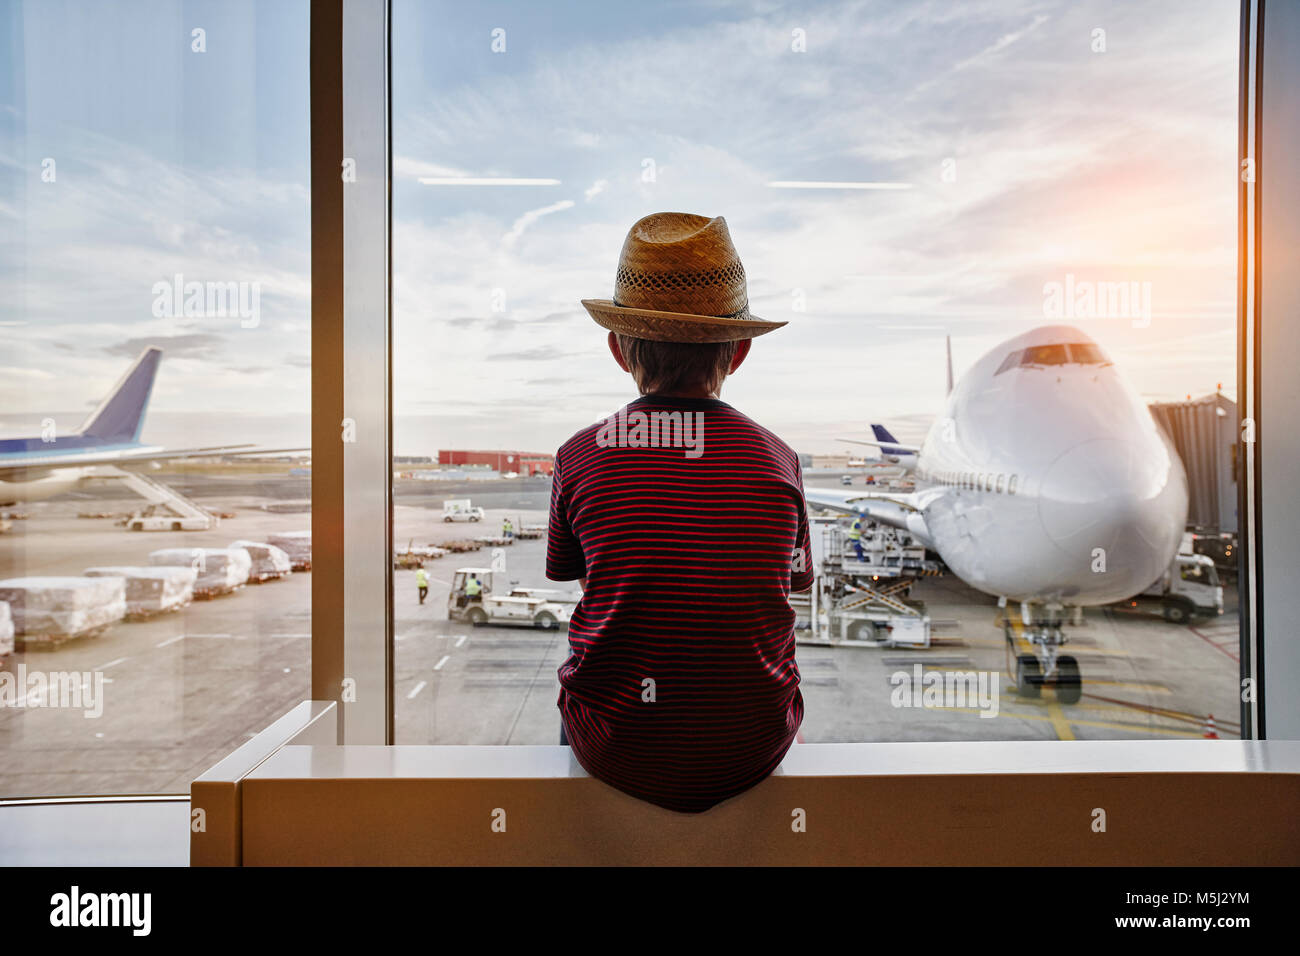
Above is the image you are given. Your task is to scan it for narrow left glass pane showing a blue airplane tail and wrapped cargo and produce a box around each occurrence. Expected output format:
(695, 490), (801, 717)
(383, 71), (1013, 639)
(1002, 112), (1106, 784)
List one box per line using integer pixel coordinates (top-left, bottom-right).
(0, 0), (311, 797)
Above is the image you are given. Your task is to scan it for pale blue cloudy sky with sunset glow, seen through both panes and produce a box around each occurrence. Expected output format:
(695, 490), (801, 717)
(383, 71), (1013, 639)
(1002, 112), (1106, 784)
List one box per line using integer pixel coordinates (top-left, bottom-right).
(0, 0), (1238, 455)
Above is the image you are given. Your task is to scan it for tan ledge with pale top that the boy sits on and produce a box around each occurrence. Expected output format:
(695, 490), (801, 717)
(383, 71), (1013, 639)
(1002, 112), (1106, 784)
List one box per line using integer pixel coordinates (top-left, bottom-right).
(191, 702), (1300, 866)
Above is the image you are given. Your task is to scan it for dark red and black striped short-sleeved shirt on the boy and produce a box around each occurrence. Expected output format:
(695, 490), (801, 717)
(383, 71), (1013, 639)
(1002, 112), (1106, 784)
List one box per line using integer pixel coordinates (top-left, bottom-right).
(546, 395), (813, 813)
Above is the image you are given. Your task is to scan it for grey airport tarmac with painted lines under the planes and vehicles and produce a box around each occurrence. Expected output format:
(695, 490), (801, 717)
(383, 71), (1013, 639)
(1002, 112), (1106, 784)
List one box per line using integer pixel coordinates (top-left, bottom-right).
(0, 473), (1240, 797)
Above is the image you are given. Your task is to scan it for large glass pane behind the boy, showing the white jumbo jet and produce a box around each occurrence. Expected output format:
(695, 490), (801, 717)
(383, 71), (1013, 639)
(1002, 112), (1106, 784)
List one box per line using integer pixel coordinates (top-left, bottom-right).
(393, 0), (1239, 744)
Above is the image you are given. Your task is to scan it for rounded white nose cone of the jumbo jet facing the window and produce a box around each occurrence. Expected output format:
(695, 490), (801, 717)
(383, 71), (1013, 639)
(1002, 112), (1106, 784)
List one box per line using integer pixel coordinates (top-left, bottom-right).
(1039, 438), (1187, 601)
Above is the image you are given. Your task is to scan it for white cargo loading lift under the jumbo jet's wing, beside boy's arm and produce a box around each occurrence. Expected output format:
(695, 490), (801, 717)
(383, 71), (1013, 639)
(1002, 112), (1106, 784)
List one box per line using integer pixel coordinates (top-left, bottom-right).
(790, 518), (941, 648)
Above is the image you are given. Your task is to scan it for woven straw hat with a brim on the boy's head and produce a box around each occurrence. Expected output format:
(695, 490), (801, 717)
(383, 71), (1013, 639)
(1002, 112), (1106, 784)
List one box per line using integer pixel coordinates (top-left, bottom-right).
(582, 212), (785, 342)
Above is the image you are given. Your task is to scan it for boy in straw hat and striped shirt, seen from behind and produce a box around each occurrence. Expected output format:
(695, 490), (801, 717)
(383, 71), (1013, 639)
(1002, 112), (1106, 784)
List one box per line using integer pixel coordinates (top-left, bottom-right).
(546, 212), (813, 813)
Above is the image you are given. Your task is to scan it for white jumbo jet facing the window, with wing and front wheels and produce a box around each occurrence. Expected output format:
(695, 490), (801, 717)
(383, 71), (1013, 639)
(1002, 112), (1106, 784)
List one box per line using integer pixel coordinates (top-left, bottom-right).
(805, 325), (1187, 701)
